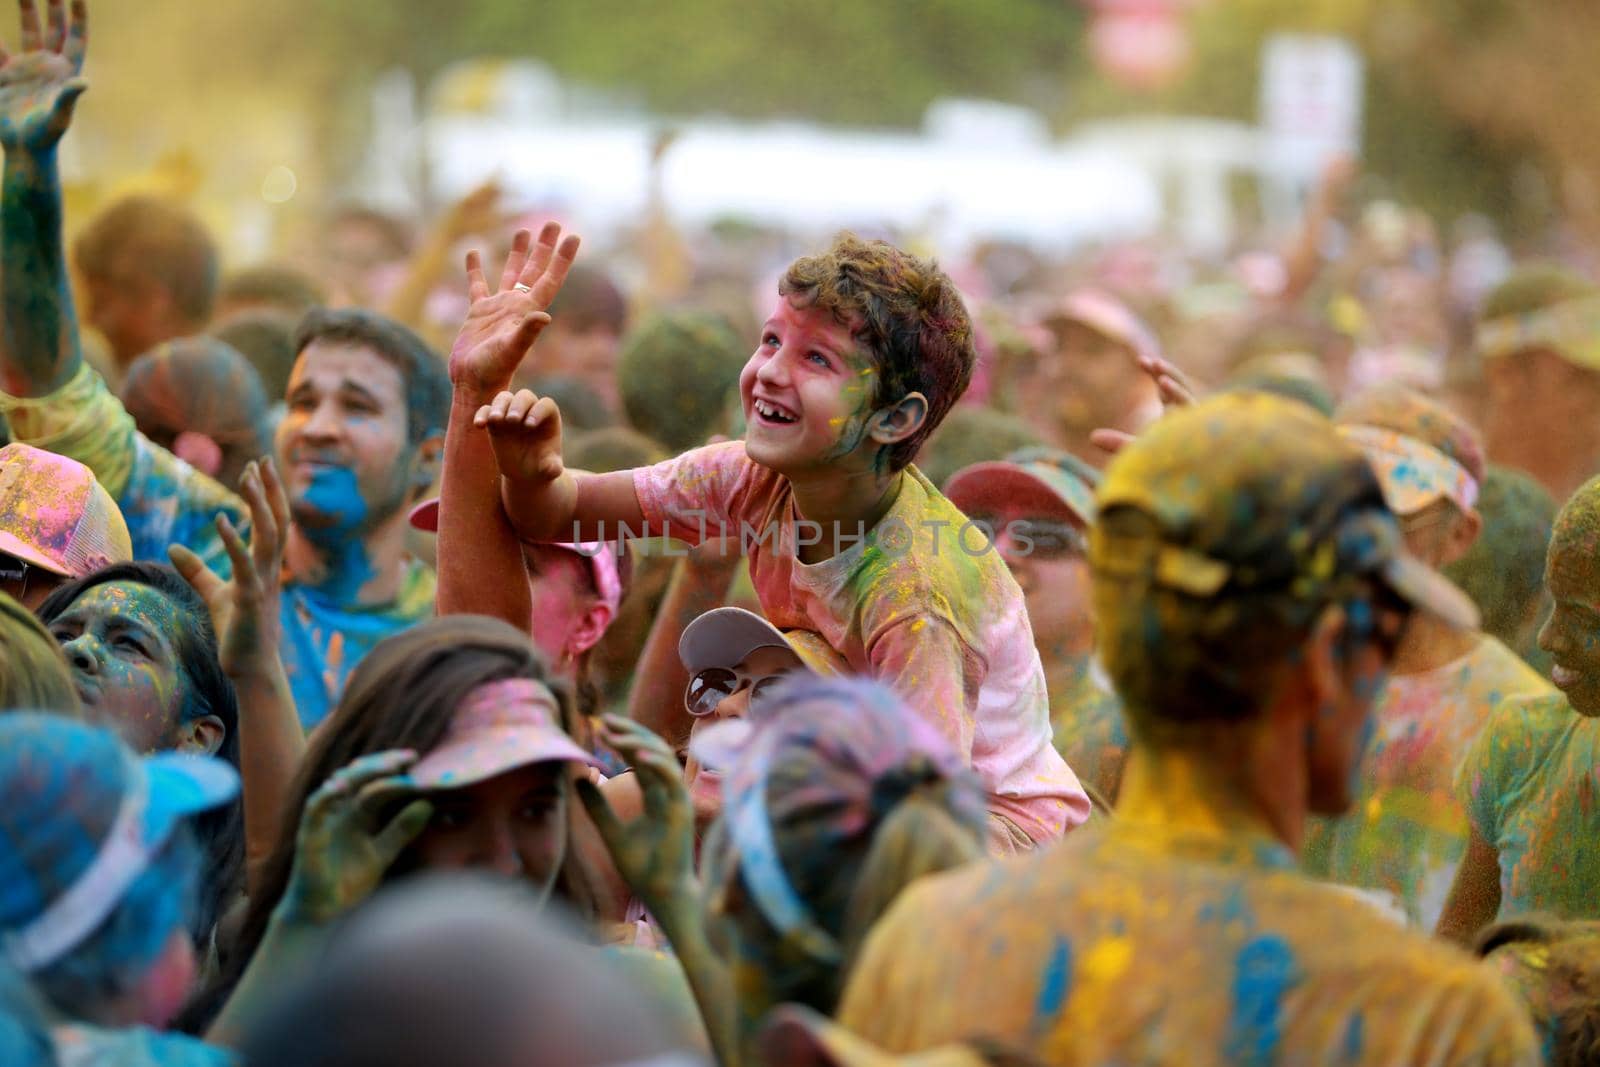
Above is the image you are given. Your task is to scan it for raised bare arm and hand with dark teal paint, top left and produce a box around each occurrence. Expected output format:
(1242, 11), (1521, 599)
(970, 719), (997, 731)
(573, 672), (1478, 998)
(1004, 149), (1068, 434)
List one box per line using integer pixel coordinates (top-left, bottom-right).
(0, 0), (88, 397)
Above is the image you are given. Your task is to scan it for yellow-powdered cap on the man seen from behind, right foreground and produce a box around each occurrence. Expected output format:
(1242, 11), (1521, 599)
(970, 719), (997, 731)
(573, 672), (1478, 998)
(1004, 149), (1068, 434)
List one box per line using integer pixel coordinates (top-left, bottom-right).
(1090, 394), (1477, 629)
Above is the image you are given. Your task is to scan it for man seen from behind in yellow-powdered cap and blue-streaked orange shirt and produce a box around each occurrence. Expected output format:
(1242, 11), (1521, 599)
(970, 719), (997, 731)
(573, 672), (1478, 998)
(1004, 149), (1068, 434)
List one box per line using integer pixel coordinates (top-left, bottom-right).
(838, 394), (1538, 1067)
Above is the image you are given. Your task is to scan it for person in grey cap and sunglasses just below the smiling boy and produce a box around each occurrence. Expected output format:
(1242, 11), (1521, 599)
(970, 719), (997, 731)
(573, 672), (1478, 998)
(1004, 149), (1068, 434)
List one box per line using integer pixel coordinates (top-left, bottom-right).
(678, 608), (805, 825)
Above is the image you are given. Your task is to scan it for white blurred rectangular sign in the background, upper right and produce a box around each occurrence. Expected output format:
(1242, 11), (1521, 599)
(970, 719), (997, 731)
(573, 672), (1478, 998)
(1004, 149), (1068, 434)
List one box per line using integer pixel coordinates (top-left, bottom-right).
(1261, 34), (1363, 182)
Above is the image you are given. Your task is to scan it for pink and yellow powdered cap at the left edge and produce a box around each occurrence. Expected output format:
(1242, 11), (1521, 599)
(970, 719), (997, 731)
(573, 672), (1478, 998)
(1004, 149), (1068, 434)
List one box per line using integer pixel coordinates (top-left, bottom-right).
(0, 445), (133, 577)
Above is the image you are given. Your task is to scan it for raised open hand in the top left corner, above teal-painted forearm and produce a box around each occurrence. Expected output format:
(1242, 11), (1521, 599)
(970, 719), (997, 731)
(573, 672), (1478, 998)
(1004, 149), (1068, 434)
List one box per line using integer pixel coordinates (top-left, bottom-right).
(0, 0), (88, 152)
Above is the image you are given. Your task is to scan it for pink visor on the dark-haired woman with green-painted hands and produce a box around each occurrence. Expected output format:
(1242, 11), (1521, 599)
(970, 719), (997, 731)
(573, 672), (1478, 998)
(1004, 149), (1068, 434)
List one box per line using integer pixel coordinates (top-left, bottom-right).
(411, 678), (600, 789)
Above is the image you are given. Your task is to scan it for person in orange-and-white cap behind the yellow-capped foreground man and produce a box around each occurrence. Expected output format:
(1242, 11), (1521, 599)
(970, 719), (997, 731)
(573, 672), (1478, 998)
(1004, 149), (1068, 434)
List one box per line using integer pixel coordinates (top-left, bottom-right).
(1304, 387), (1554, 929)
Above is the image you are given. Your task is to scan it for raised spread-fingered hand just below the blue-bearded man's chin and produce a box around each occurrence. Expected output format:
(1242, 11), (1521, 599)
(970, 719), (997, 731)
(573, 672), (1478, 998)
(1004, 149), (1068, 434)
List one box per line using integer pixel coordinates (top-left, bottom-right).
(166, 459), (290, 678)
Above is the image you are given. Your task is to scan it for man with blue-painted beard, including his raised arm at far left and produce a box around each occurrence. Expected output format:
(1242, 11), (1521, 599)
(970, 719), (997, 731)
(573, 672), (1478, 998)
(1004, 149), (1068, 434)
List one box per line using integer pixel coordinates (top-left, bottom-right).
(0, 0), (450, 728)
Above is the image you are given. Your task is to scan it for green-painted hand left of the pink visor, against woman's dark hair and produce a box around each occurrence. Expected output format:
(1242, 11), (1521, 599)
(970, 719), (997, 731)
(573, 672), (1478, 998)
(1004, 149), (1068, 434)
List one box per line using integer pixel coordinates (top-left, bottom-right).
(278, 749), (434, 925)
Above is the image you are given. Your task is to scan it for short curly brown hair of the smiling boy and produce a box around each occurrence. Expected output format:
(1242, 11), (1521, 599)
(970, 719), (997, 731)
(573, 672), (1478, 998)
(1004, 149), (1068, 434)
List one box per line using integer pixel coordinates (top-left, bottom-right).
(778, 234), (978, 470)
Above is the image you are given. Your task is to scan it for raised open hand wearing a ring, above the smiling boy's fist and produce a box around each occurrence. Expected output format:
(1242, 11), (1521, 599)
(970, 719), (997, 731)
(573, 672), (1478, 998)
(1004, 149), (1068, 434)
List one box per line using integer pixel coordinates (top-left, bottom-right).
(450, 222), (578, 398)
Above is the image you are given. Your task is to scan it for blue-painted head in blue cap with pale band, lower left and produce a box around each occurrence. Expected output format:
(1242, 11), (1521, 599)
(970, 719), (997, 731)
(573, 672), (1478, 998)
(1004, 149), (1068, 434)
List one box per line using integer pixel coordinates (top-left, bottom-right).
(0, 712), (238, 1025)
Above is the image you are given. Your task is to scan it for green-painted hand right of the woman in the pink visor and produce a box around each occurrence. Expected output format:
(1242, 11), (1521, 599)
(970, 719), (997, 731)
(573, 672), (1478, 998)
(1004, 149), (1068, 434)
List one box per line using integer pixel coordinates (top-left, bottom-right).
(578, 715), (699, 921)
